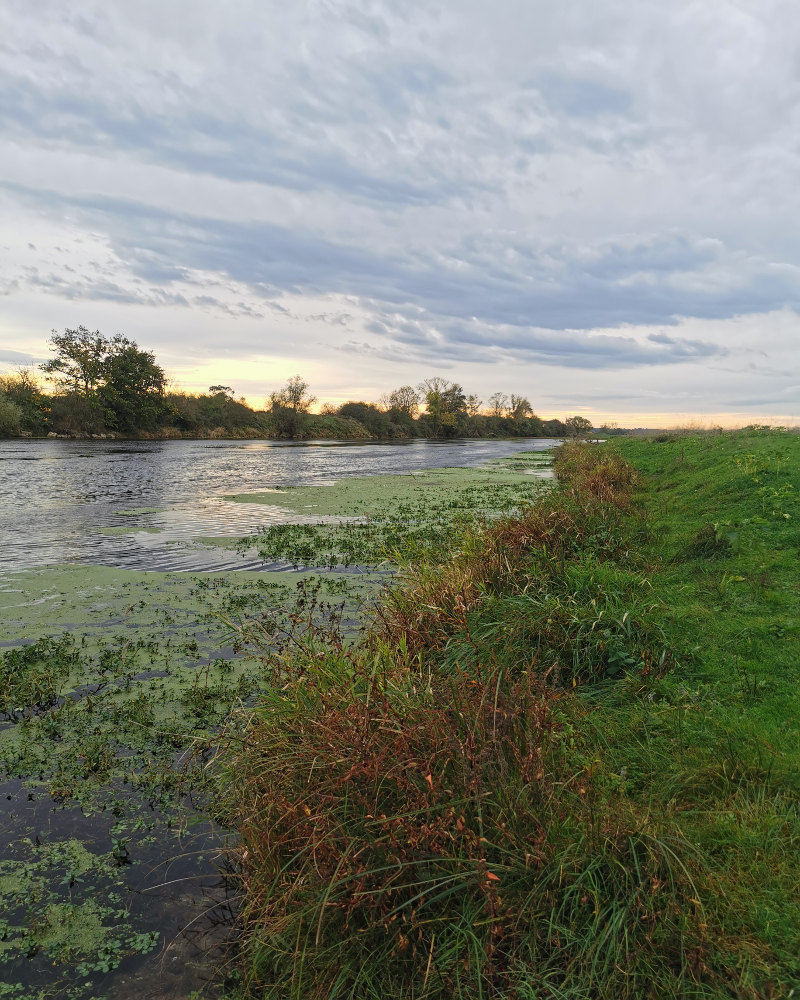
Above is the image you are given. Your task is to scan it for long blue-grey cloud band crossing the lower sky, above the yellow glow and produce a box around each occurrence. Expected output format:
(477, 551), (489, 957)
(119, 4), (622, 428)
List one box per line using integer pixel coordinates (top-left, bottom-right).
(6, 187), (800, 367)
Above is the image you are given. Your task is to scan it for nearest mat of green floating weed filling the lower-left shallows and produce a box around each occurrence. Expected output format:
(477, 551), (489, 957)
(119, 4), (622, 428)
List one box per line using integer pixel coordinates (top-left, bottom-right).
(0, 566), (374, 1000)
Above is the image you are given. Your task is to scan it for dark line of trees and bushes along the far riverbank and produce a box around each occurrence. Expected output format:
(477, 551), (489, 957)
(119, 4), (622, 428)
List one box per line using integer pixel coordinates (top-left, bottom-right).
(0, 326), (615, 439)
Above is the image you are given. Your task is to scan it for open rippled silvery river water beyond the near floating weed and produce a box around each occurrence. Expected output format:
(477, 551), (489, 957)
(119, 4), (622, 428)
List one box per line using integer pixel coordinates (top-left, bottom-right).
(0, 439), (556, 571)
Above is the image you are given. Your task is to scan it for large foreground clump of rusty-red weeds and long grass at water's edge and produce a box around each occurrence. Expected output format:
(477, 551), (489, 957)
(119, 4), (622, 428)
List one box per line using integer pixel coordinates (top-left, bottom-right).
(222, 645), (691, 998)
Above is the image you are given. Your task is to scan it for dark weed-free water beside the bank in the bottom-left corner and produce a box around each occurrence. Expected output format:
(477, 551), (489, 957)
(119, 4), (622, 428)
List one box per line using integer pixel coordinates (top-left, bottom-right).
(0, 779), (235, 1000)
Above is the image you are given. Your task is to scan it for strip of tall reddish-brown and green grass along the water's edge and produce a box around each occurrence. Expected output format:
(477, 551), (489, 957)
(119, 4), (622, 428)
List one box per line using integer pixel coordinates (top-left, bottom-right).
(216, 446), (728, 998)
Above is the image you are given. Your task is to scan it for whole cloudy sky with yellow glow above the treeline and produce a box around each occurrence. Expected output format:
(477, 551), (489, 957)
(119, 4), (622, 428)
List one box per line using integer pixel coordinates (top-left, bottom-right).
(0, 0), (800, 426)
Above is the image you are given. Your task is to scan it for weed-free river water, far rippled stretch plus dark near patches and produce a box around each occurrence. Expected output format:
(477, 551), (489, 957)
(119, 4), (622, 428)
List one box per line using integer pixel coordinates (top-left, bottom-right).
(0, 439), (558, 1000)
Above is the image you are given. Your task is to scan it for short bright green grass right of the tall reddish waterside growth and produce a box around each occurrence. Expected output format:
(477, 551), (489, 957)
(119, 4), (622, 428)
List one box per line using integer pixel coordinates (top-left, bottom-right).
(590, 431), (800, 996)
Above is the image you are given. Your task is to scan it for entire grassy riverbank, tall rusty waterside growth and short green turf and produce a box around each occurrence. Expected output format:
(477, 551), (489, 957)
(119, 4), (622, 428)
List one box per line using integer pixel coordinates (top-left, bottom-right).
(220, 431), (800, 1000)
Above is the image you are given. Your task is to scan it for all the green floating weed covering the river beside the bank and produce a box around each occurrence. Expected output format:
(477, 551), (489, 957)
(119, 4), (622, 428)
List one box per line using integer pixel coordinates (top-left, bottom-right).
(0, 450), (552, 1000)
